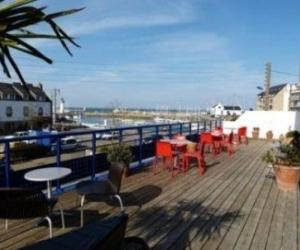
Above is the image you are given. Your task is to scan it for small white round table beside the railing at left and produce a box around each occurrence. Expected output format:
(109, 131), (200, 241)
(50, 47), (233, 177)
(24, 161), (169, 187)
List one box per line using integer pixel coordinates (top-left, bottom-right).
(24, 167), (72, 199)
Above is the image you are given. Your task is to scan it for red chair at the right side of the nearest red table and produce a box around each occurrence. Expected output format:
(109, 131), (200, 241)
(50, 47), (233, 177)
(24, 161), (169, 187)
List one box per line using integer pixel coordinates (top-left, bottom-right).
(183, 143), (206, 175)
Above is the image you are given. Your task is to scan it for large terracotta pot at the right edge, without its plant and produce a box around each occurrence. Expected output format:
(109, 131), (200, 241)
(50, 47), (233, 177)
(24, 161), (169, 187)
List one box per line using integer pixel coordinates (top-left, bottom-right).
(274, 165), (300, 191)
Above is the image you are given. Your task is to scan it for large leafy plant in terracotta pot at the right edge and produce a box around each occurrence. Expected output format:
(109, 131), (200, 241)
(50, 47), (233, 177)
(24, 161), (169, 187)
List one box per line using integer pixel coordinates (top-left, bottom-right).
(262, 131), (300, 191)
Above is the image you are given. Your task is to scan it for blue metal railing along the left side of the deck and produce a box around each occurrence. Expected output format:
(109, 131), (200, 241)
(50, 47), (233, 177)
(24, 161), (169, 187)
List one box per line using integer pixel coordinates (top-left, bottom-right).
(0, 120), (222, 190)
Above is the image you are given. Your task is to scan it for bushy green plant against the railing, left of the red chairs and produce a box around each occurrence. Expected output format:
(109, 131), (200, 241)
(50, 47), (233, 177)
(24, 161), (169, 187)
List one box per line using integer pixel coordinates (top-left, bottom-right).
(103, 143), (133, 177)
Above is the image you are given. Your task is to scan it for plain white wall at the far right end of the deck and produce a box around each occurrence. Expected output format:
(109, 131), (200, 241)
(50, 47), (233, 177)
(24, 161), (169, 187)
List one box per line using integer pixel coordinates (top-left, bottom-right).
(223, 111), (300, 139)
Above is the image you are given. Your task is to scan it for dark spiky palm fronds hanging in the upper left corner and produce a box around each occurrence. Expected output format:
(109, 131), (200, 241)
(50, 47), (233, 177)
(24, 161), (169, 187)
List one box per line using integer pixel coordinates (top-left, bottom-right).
(0, 0), (82, 96)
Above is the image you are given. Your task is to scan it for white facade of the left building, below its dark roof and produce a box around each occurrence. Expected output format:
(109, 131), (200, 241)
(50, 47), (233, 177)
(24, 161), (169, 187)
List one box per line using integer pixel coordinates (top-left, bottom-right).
(0, 100), (51, 122)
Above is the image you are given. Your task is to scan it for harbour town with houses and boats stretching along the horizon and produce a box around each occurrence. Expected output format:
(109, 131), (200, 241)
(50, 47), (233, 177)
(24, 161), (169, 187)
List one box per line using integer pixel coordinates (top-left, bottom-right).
(0, 79), (300, 135)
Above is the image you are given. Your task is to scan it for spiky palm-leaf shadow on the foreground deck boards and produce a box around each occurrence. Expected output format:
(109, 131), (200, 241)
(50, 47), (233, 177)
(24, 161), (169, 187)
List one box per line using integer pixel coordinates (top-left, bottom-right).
(133, 201), (243, 249)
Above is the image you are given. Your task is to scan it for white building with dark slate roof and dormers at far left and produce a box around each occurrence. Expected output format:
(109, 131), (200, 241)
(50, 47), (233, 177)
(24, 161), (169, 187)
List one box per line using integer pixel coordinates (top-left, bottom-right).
(0, 82), (52, 133)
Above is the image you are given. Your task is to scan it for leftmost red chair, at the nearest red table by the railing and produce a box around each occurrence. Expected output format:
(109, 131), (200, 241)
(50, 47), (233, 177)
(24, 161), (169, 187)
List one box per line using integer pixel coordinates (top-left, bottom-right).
(153, 141), (178, 174)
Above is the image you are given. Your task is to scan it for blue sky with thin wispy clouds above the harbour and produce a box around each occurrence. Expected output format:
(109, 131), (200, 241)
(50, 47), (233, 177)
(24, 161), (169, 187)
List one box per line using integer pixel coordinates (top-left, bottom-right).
(5, 0), (300, 108)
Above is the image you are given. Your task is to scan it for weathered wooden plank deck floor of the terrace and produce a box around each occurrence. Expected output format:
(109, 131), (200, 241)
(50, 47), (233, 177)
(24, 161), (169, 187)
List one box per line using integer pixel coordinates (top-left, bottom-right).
(0, 141), (300, 250)
